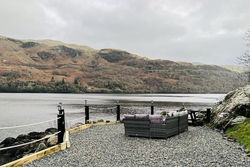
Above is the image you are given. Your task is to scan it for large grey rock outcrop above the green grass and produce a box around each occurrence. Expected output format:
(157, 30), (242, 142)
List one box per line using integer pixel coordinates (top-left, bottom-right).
(212, 85), (250, 129)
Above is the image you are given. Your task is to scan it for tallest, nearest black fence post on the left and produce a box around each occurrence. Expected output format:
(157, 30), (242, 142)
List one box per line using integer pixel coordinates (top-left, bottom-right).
(57, 103), (65, 144)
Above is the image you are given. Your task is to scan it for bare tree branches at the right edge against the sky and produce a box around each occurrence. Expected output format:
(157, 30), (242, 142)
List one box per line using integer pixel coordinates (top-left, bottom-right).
(237, 29), (250, 84)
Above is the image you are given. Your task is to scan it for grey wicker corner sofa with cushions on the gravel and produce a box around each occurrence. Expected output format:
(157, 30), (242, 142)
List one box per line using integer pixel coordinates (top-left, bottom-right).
(123, 112), (188, 138)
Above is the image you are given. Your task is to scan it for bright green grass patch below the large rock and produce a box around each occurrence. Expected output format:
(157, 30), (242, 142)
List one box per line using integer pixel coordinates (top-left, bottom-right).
(226, 118), (250, 150)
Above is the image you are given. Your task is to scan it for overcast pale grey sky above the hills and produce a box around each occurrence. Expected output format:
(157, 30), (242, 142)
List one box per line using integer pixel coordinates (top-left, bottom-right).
(0, 0), (250, 64)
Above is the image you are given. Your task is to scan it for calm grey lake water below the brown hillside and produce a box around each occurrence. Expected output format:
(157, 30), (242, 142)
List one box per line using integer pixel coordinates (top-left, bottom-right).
(0, 93), (225, 140)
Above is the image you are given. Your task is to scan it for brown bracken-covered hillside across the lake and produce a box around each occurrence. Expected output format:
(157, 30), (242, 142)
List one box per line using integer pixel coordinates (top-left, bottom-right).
(0, 36), (246, 93)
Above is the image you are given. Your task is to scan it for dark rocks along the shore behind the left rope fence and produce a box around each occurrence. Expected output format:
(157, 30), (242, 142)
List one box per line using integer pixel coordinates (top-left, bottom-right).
(0, 128), (57, 165)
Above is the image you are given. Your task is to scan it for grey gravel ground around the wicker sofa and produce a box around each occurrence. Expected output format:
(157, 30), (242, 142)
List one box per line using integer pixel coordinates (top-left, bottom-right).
(26, 124), (250, 167)
